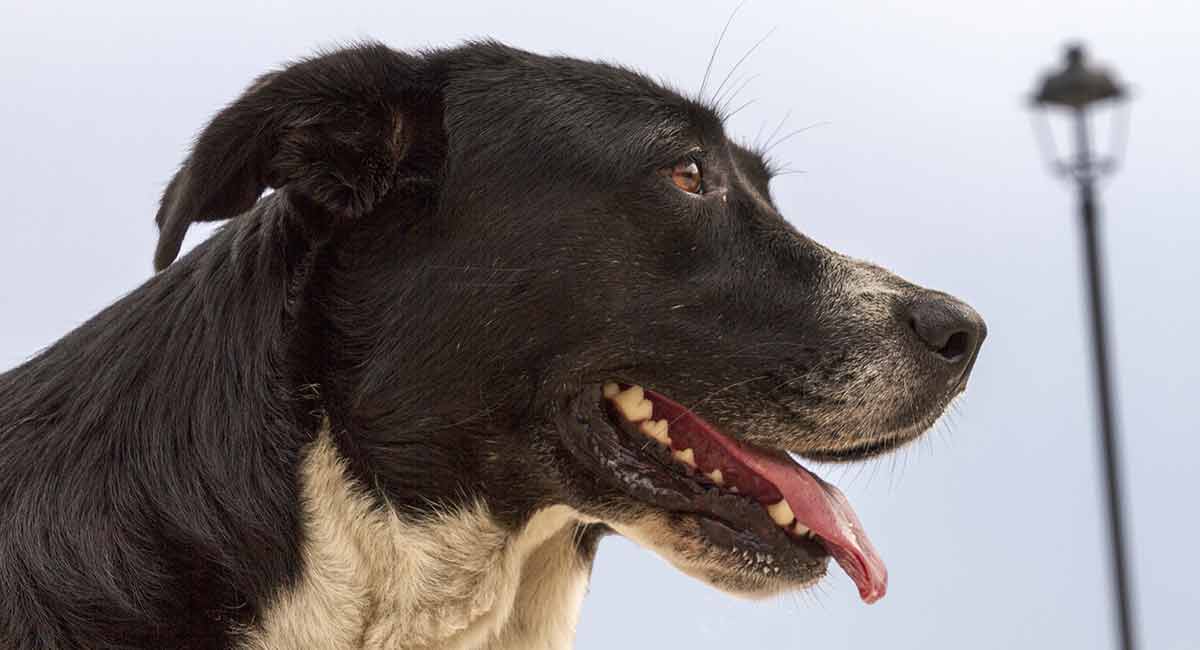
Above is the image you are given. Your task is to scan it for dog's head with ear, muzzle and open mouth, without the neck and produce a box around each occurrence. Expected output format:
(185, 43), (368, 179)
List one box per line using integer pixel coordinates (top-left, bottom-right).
(156, 43), (985, 601)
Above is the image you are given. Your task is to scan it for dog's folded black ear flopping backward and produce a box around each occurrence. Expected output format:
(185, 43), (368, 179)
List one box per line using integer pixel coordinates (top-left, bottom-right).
(155, 44), (442, 270)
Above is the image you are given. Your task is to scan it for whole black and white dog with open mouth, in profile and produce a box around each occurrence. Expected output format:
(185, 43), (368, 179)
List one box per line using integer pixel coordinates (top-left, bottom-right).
(0, 41), (986, 650)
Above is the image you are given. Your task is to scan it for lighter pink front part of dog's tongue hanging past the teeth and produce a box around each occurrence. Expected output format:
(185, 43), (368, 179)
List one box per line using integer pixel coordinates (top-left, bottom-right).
(730, 445), (888, 603)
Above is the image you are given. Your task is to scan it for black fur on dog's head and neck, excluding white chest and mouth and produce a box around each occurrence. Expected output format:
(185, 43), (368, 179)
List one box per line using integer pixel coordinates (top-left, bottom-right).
(0, 42), (982, 648)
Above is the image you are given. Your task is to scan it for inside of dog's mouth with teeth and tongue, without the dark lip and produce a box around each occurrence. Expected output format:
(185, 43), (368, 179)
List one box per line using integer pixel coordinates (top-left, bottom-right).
(602, 383), (888, 603)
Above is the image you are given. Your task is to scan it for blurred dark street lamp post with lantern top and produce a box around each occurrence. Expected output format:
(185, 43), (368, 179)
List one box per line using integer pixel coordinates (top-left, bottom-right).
(1033, 46), (1136, 650)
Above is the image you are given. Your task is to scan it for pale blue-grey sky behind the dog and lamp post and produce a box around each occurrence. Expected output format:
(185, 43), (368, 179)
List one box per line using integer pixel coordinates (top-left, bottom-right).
(0, 0), (1200, 650)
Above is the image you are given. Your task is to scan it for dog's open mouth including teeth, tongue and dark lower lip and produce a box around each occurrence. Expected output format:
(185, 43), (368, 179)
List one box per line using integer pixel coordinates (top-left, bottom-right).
(581, 383), (887, 603)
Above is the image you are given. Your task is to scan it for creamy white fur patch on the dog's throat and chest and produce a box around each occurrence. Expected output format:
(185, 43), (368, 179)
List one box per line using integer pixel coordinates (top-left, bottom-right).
(241, 432), (590, 650)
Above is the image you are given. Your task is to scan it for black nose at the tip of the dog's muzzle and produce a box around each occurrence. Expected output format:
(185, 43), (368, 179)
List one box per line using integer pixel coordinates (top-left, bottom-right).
(908, 291), (988, 373)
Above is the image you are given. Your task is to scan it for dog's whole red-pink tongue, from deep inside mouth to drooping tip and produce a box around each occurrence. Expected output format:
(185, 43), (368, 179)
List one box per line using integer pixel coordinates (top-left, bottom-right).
(646, 391), (888, 603)
